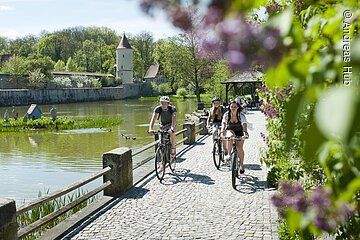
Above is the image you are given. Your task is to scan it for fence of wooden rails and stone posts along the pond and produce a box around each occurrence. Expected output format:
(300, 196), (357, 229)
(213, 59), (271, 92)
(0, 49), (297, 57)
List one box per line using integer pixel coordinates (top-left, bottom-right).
(0, 117), (207, 240)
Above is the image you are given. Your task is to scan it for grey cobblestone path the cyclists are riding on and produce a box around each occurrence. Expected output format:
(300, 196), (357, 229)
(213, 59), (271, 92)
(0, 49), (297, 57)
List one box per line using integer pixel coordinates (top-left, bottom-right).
(65, 112), (277, 240)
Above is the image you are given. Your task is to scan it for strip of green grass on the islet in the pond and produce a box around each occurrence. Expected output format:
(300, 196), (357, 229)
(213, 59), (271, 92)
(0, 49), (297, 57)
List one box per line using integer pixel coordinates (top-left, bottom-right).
(0, 116), (123, 132)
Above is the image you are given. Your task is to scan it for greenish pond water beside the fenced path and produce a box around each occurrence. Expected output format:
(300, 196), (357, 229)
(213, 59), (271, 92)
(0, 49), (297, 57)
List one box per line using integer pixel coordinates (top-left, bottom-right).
(0, 99), (197, 205)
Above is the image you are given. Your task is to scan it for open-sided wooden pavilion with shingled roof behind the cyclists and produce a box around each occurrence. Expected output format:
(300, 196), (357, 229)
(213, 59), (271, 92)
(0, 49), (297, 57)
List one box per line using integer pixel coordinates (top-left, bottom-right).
(221, 71), (263, 103)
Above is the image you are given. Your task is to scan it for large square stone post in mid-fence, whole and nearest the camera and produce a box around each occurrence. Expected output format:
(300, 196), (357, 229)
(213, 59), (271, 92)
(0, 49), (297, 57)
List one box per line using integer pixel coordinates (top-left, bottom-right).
(103, 147), (133, 197)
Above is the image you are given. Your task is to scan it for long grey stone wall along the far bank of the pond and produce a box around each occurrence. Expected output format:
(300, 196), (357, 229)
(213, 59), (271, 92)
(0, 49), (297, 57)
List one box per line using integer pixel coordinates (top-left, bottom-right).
(0, 83), (151, 106)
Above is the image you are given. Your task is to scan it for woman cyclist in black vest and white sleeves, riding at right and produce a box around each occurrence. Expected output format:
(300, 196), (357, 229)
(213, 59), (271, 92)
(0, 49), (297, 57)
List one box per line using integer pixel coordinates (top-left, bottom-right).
(221, 100), (249, 174)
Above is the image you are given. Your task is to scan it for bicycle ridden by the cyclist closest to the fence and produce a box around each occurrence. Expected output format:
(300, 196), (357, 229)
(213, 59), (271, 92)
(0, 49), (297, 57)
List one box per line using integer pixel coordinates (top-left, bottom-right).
(153, 130), (176, 181)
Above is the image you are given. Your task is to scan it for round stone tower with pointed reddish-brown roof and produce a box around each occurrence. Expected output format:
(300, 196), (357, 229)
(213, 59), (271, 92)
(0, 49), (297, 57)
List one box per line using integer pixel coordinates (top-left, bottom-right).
(116, 33), (134, 84)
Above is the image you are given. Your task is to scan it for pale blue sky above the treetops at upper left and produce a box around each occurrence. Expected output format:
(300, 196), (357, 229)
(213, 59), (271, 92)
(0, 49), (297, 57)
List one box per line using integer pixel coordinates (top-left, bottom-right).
(0, 0), (180, 40)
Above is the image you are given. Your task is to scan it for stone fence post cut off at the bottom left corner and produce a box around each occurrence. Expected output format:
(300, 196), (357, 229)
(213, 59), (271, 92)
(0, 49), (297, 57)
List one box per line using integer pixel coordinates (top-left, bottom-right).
(0, 198), (18, 240)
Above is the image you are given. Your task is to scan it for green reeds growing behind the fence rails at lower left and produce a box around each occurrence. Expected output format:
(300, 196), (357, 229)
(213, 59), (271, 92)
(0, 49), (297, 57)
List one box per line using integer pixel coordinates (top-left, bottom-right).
(17, 189), (98, 240)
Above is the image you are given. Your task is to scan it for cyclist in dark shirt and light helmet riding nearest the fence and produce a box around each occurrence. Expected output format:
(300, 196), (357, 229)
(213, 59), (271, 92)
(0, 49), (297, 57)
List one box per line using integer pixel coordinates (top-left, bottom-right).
(149, 96), (176, 156)
